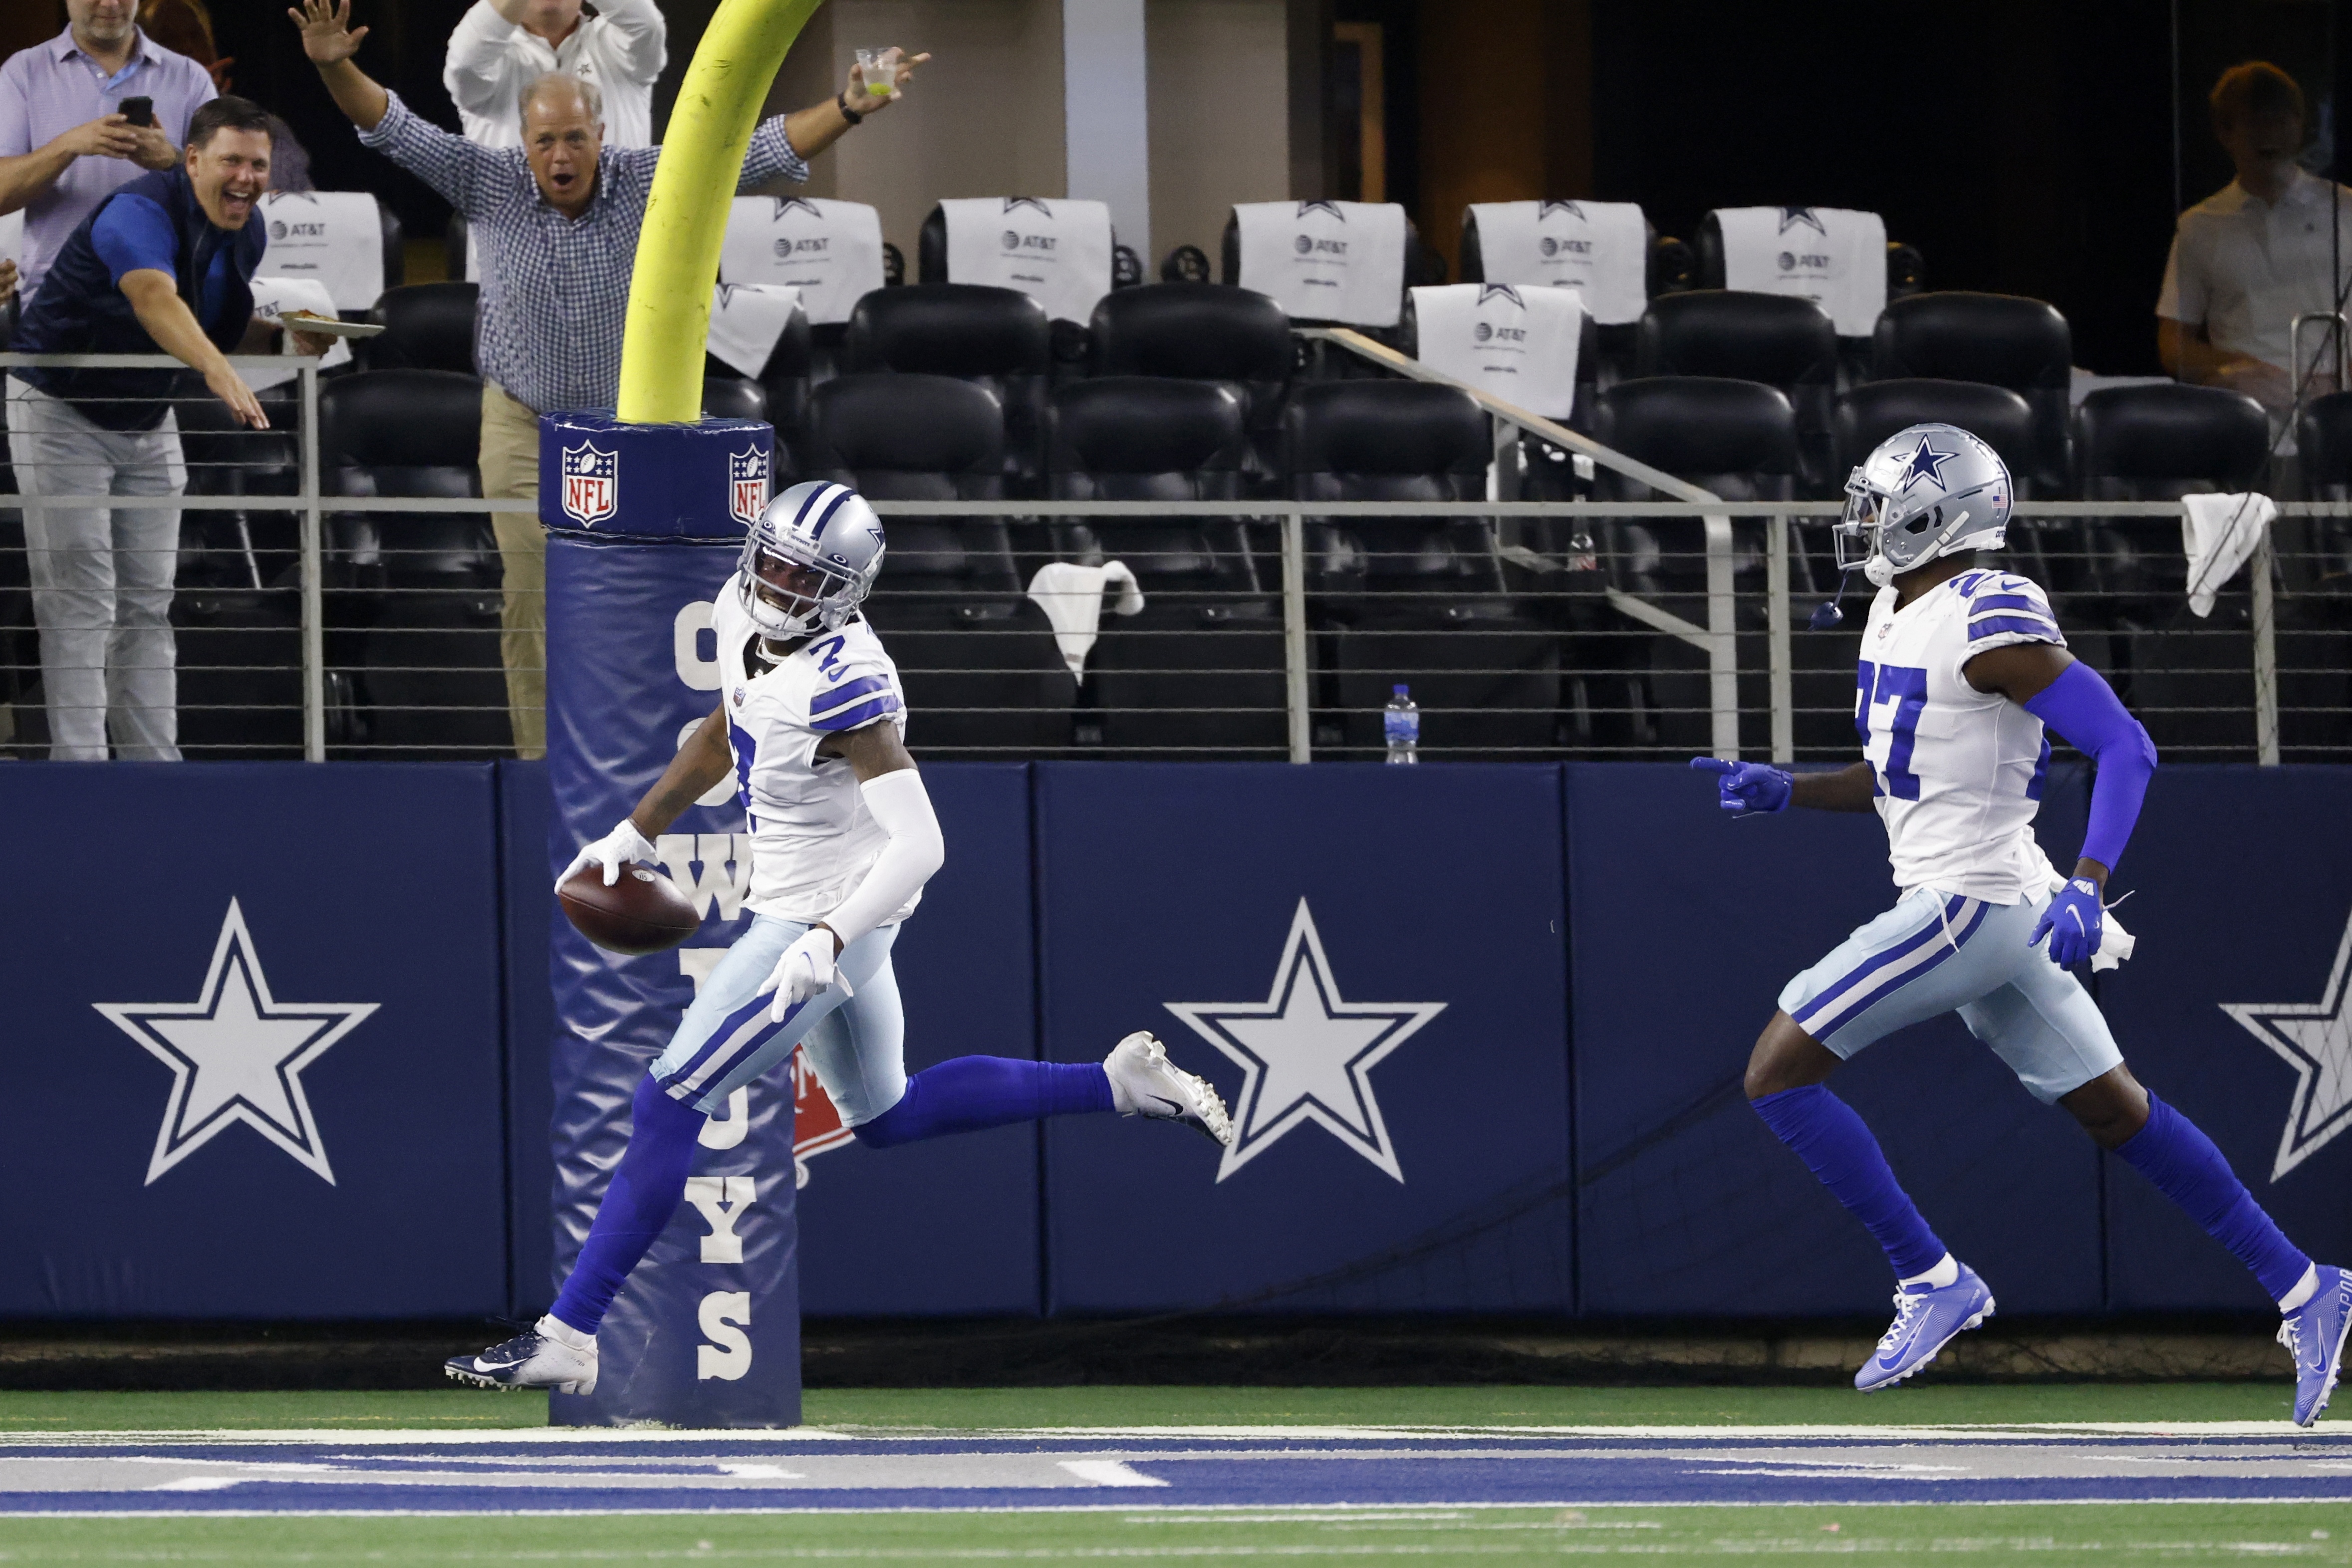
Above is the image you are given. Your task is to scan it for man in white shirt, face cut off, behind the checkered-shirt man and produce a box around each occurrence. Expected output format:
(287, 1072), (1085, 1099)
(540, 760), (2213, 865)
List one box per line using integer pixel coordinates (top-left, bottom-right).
(442, 0), (668, 148)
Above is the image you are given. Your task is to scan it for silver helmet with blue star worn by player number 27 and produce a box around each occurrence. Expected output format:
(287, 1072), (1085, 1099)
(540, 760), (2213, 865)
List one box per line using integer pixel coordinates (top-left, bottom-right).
(1834, 426), (2016, 588)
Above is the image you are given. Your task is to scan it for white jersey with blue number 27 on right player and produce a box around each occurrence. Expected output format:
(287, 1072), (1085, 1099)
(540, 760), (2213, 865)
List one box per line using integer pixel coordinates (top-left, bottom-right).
(1853, 571), (2065, 903)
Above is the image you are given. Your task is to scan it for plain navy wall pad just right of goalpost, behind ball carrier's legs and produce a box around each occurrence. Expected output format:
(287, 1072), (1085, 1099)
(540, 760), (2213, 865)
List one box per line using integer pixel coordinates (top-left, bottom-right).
(799, 766), (1037, 1316)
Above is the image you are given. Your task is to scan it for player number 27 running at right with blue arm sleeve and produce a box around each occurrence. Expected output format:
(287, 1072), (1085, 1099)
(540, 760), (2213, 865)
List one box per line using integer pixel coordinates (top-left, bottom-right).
(1691, 426), (2352, 1427)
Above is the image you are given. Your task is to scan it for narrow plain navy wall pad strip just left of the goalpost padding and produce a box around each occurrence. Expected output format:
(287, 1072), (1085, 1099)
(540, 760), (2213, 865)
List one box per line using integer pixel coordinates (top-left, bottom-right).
(499, 762), (562, 1321)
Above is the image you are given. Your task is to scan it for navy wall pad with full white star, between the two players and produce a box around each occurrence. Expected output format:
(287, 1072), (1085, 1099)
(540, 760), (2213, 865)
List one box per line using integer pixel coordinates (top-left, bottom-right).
(1040, 764), (1571, 1314)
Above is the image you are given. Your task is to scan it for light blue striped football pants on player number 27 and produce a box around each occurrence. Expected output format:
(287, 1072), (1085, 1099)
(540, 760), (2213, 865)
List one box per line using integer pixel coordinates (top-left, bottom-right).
(1781, 889), (2124, 1102)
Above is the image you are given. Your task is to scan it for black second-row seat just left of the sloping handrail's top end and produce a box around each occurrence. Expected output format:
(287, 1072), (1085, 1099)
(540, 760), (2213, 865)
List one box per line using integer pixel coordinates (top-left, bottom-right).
(1086, 282), (1296, 487)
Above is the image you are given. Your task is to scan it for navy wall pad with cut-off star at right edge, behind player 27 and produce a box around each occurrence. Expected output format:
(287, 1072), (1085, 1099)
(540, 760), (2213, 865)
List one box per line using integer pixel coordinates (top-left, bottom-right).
(2100, 767), (2352, 1312)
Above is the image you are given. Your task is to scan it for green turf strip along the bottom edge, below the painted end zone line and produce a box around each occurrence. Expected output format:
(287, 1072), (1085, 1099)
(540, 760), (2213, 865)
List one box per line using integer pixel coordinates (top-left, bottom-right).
(0, 1502), (2352, 1568)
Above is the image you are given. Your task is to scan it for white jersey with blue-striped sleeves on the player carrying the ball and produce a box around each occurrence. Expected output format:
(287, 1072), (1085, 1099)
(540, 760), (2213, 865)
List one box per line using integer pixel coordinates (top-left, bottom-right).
(710, 573), (922, 924)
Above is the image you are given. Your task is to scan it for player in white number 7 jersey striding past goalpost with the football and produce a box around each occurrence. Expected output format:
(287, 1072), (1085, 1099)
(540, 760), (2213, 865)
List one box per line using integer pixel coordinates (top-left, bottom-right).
(447, 484), (1233, 1394)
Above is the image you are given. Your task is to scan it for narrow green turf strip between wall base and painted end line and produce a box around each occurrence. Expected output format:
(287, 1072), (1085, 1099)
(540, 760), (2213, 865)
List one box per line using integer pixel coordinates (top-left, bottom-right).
(0, 1377), (2293, 1432)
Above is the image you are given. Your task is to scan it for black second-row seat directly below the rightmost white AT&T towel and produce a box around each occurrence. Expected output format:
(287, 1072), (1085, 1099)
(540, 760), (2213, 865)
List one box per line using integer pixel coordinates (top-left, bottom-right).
(1635, 289), (1846, 494)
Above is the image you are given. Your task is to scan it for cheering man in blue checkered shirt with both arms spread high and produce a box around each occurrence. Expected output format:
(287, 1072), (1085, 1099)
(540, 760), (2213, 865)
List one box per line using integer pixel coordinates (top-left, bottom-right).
(291, 0), (931, 757)
